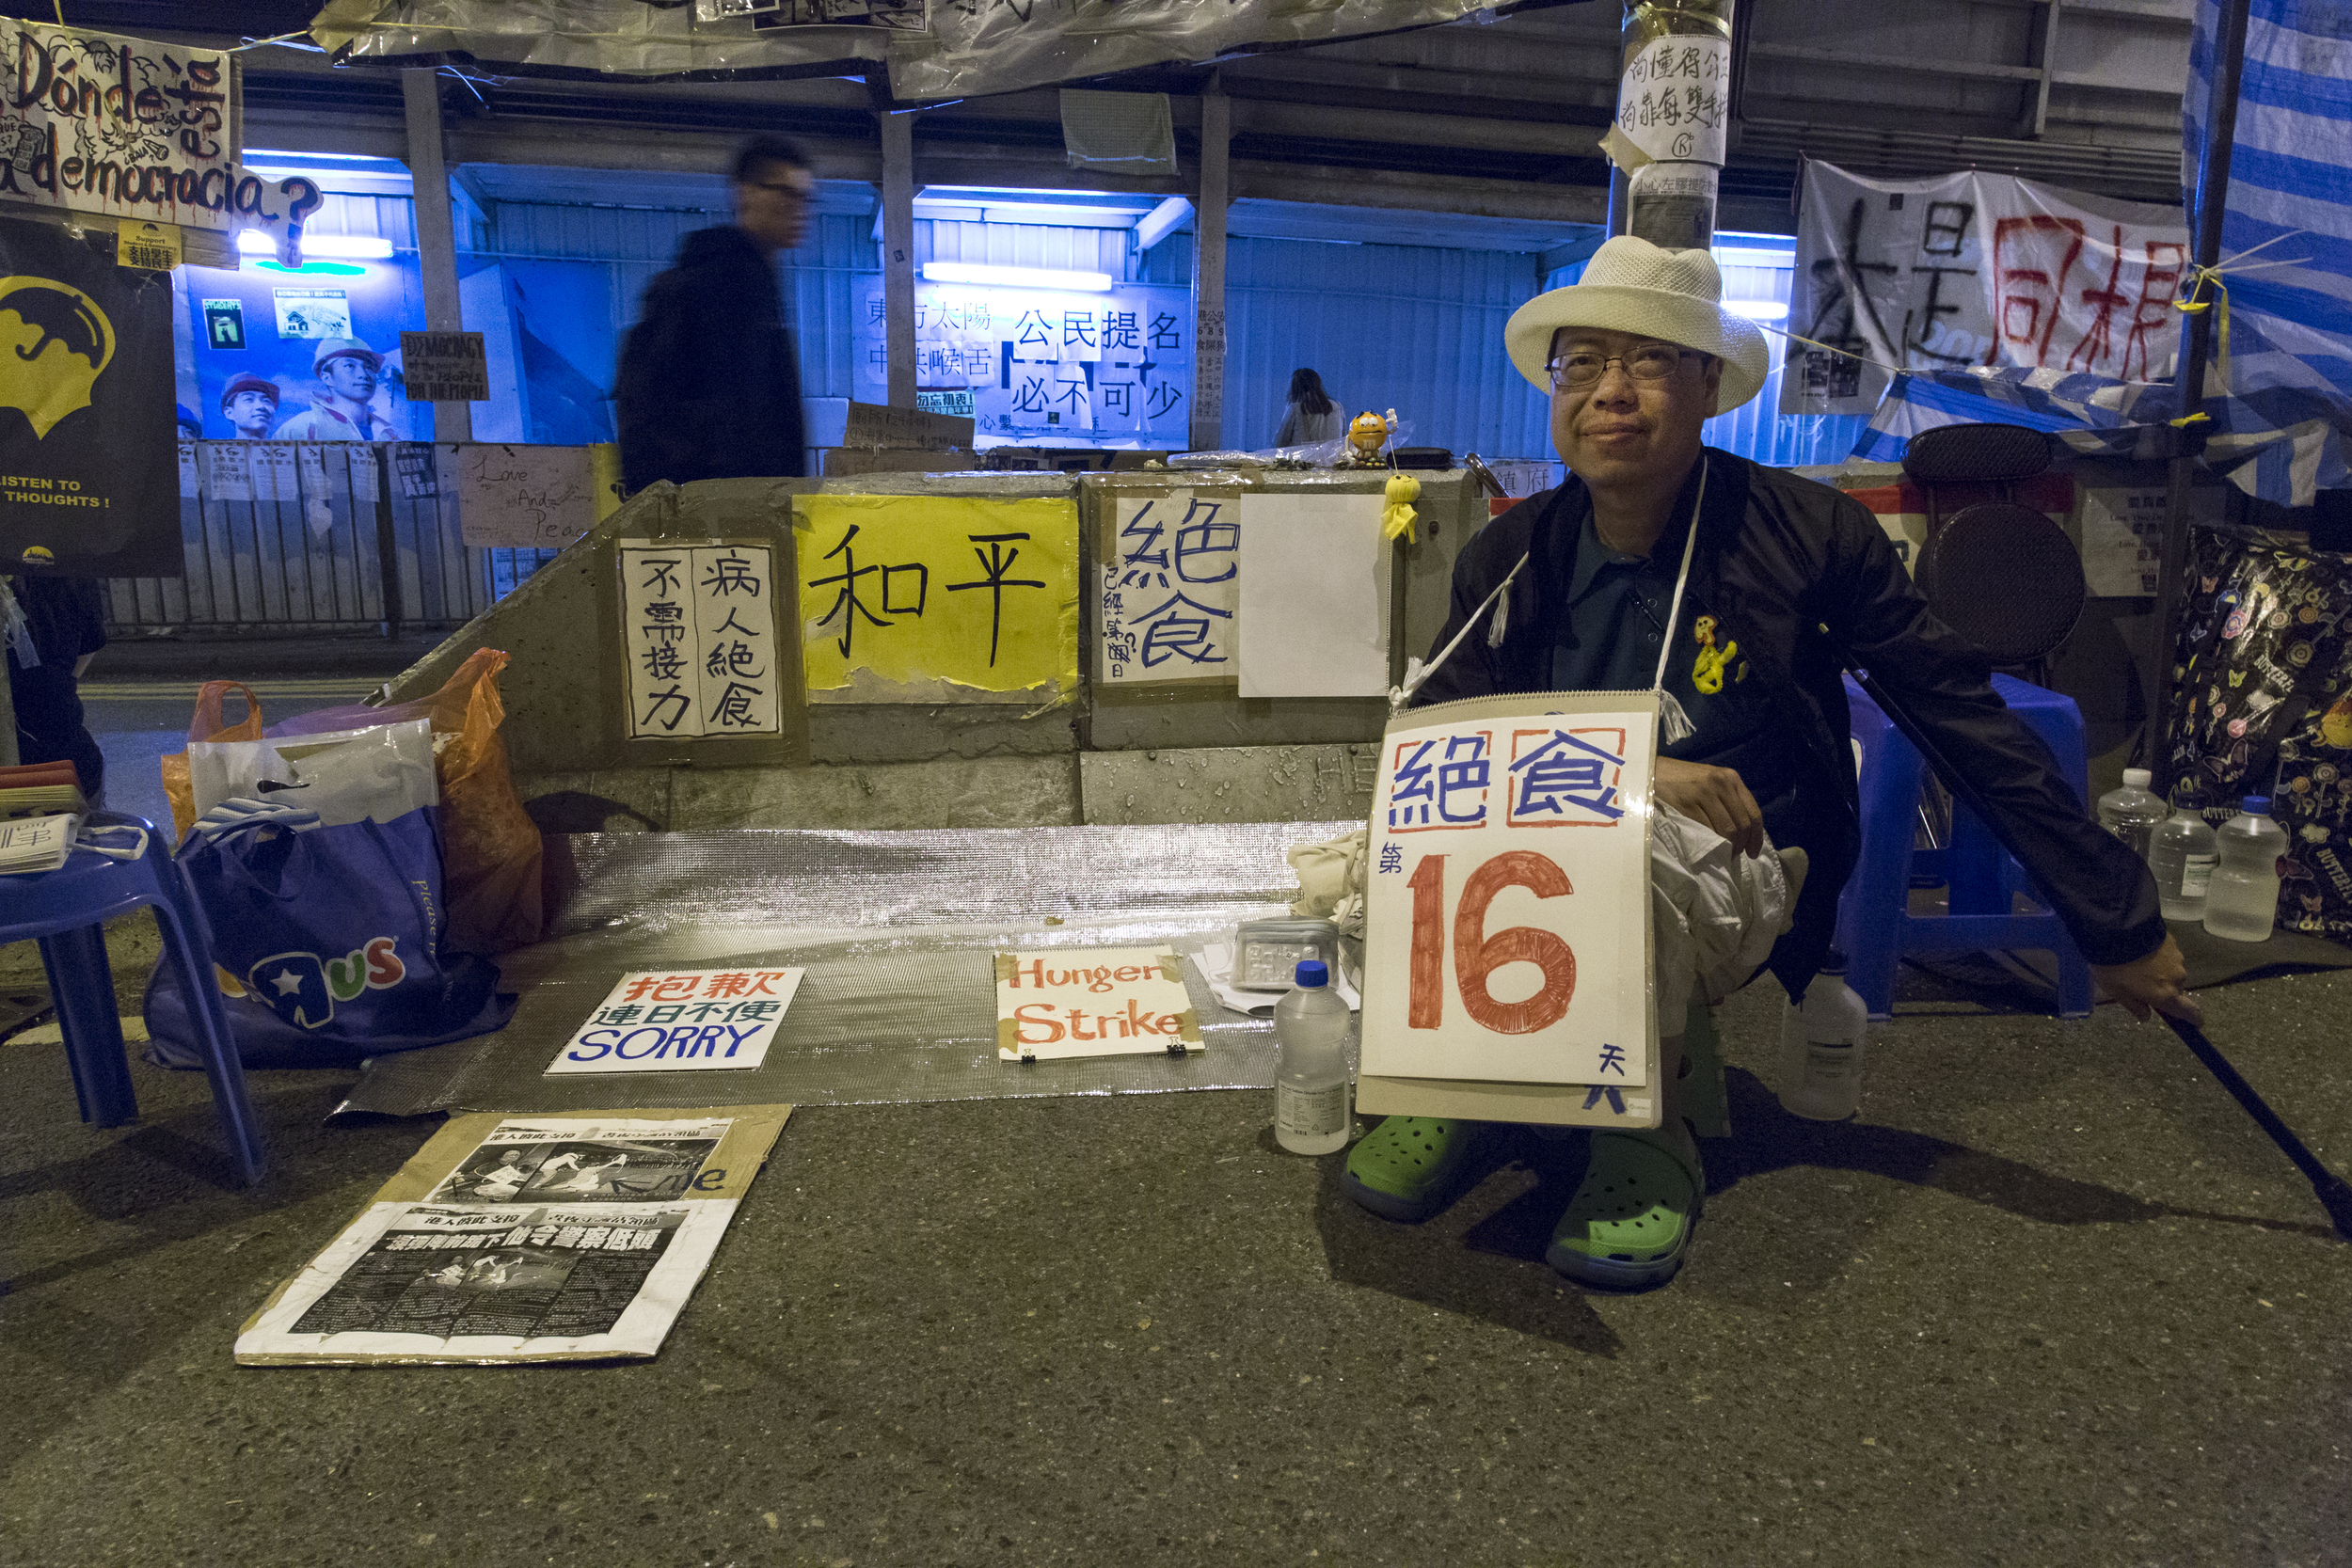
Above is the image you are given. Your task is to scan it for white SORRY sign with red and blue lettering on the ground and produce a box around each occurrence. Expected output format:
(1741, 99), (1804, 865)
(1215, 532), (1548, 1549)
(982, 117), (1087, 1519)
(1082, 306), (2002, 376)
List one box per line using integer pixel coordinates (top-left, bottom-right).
(548, 969), (803, 1077)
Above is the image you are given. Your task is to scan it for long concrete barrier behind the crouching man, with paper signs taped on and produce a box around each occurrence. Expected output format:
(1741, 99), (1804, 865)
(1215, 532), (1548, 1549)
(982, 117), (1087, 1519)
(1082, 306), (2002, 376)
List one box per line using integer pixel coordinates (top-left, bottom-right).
(389, 470), (1486, 832)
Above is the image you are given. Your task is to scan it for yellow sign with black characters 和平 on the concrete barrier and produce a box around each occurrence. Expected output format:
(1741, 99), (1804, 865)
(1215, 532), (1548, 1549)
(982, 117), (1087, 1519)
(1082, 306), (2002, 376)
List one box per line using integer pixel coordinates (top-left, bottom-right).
(793, 496), (1077, 703)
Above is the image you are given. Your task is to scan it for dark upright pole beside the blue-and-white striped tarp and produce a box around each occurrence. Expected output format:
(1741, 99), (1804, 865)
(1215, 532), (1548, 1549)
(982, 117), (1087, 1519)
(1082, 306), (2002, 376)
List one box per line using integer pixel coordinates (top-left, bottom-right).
(2140, 0), (2251, 800)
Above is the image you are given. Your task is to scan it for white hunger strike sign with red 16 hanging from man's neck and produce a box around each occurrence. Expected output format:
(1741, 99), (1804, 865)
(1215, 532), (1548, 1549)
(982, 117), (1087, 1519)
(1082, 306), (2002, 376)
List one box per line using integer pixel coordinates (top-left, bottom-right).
(1359, 691), (1659, 1126)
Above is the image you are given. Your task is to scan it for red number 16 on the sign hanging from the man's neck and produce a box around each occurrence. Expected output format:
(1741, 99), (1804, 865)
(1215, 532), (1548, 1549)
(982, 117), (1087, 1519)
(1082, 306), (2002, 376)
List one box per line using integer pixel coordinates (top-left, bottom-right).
(1405, 848), (1576, 1035)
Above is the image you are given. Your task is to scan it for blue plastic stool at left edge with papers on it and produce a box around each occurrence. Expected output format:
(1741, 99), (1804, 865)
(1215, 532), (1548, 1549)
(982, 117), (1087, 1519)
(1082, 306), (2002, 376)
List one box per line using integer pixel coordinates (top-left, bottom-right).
(0, 811), (268, 1185)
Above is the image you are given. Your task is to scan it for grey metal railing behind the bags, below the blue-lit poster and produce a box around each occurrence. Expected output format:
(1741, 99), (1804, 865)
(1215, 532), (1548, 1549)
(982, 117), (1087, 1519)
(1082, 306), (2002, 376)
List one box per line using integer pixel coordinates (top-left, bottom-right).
(106, 442), (555, 635)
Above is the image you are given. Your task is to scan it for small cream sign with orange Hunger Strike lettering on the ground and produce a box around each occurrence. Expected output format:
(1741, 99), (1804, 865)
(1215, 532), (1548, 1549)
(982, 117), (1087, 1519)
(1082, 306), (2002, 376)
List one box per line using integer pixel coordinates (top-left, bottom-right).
(997, 947), (1202, 1063)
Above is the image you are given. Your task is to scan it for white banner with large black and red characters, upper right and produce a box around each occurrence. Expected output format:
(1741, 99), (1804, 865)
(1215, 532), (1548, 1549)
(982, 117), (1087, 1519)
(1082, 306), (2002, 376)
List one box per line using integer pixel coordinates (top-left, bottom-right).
(1781, 162), (2187, 414)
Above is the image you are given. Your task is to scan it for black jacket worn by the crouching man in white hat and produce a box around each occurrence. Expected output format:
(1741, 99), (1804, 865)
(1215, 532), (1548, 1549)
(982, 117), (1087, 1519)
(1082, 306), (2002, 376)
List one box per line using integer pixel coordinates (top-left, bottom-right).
(1414, 449), (2164, 994)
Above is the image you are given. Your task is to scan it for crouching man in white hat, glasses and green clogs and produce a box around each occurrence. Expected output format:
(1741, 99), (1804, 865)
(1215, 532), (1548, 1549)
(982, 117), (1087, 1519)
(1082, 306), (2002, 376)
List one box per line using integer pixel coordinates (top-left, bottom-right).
(1345, 235), (2197, 1286)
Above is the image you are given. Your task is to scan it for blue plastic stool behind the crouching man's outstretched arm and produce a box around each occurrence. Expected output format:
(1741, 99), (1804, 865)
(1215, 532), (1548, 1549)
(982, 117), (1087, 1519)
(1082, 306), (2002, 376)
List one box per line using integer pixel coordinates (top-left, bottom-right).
(1837, 674), (2091, 1018)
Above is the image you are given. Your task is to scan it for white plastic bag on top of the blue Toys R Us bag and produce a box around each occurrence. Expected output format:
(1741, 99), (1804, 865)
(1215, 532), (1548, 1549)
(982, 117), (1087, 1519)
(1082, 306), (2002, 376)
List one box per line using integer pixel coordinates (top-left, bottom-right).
(188, 720), (440, 828)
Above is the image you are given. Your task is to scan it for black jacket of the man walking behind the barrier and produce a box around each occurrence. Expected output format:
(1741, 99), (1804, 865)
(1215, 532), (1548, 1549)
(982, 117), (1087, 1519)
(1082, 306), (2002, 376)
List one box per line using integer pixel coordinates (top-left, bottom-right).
(614, 223), (809, 491)
